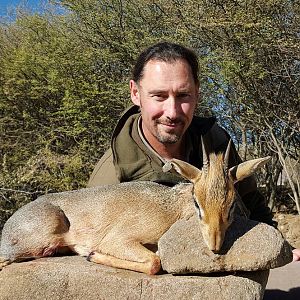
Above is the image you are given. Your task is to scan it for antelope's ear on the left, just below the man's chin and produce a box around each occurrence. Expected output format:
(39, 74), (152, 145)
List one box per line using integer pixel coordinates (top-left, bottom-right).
(163, 158), (201, 183)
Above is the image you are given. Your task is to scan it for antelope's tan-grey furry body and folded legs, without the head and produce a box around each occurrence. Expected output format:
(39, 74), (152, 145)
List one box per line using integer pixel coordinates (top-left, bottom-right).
(0, 182), (194, 274)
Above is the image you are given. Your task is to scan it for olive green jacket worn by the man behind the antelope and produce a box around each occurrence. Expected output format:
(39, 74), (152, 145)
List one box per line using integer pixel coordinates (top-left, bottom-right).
(88, 106), (273, 225)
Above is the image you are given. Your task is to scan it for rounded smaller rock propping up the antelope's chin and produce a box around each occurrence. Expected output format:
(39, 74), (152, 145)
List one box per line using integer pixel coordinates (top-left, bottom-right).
(158, 217), (293, 274)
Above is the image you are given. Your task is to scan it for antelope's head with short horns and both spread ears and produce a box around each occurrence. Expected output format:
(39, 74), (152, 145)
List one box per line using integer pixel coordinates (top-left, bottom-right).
(165, 140), (270, 252)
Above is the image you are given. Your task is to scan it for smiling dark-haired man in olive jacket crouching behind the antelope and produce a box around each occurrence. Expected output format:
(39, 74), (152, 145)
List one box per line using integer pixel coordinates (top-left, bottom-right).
(88, 42), (300, 260)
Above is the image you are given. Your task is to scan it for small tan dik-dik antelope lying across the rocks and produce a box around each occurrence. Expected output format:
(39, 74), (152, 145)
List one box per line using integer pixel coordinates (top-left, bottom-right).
(0, 141), (269, 274)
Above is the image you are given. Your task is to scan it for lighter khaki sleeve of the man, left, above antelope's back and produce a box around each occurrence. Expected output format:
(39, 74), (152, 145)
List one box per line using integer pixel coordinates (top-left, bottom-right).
(87, 148), (119, 187)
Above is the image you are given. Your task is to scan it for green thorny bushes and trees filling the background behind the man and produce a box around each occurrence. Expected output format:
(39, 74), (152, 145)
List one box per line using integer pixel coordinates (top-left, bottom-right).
(0, 0), (300, 227)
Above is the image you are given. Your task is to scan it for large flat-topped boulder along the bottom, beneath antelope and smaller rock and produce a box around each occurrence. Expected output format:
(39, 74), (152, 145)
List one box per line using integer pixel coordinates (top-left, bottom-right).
(0, 256), (269, 300)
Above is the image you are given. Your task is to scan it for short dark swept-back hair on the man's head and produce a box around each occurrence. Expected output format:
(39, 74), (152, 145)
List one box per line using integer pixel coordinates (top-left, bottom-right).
(132, 42), (199, 84)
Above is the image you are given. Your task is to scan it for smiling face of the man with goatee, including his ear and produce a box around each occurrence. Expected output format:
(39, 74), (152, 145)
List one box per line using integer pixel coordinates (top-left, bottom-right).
(130, 60), (199, 144)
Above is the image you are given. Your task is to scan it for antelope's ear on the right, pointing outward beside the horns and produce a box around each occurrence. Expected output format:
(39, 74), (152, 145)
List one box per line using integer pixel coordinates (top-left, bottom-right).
(229, 156), (271, 182)
